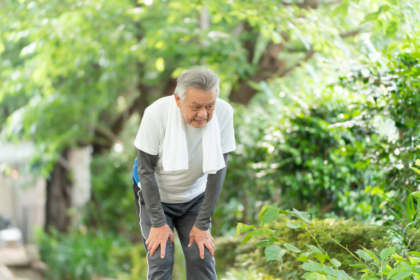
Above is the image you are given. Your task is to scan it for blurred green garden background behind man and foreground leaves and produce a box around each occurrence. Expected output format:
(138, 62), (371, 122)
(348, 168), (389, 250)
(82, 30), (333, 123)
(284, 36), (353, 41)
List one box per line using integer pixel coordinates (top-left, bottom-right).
(0, 0), (420, 280)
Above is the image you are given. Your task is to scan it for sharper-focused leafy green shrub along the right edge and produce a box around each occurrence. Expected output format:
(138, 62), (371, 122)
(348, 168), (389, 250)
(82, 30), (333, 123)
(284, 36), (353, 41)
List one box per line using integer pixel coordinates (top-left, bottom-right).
(334, 30), (420, 250)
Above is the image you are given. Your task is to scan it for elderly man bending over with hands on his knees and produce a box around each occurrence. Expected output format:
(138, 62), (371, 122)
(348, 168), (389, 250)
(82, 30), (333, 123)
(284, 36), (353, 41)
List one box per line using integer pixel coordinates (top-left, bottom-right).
(133, 67), (236, 280)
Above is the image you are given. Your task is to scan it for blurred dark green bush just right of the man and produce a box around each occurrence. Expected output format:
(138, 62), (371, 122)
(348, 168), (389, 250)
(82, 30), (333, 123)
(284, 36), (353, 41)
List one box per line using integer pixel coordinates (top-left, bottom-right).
(216, 81), (383, 234)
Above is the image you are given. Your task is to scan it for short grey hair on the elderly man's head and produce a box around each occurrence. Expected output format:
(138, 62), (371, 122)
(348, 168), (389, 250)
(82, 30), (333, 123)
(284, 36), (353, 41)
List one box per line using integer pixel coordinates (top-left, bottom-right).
(175, 66), (220, 101)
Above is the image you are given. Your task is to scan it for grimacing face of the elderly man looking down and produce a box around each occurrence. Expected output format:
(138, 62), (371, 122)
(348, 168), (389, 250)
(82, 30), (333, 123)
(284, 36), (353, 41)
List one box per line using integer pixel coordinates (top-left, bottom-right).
(175, 88), (217, 128)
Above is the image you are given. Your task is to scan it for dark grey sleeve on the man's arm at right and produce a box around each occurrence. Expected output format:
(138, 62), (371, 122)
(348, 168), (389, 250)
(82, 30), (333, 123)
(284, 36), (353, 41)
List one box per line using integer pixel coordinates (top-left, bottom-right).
(194, 153), (229, 230)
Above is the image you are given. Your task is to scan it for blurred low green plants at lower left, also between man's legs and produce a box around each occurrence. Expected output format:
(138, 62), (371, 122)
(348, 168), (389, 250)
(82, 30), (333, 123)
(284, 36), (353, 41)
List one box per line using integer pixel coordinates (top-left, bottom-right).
(37, 226), (186, 280)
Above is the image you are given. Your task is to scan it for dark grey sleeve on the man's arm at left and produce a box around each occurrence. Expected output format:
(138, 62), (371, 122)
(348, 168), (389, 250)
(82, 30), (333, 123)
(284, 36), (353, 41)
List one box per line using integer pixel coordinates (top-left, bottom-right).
(137, 150), (166, 227)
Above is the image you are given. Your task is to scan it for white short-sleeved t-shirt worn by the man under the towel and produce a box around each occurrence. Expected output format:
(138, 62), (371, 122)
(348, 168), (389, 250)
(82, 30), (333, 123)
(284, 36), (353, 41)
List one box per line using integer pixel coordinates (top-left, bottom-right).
(134, 96), (236, 203)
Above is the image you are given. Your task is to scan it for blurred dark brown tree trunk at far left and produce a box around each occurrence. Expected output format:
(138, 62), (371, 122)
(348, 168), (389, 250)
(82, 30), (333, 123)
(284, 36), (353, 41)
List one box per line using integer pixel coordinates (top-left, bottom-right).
(45, 148), (72, 232)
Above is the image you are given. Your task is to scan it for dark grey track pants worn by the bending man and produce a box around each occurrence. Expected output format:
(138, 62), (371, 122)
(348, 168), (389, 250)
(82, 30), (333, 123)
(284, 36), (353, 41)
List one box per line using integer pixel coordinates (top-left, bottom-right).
(133, 182), (217, 280)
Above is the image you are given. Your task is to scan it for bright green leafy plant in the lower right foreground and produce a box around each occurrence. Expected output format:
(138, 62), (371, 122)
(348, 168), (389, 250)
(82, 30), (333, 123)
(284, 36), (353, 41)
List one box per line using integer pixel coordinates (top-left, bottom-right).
(236, 205), (420, 280)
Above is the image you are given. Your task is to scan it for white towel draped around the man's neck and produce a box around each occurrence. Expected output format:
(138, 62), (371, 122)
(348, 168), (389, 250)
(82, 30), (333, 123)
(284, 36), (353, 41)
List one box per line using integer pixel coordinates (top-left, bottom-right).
(163, 98), (226, 174)
